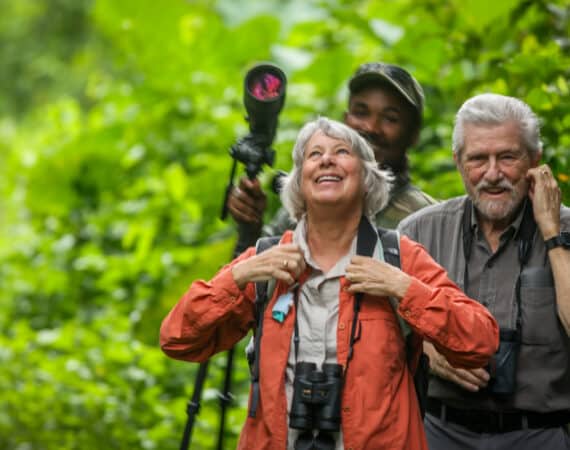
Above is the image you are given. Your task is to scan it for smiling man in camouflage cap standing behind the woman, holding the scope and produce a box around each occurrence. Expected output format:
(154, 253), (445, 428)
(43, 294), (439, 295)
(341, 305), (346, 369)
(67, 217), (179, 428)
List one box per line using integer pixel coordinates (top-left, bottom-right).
(228, 62), (436, 253)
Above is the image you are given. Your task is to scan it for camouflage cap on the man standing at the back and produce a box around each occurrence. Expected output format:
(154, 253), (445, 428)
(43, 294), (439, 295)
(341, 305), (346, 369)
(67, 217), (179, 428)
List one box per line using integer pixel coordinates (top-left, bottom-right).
(348, 62), (424, 117)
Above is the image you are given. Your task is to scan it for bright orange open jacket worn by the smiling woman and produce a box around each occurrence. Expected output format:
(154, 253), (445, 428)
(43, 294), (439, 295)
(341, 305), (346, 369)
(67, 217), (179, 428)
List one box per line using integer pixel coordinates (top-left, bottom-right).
(160, 232), (498, 450)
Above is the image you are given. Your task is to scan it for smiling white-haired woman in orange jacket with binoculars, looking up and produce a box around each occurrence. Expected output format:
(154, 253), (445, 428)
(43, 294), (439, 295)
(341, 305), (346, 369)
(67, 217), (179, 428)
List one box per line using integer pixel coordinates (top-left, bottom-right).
(160, 118), (498, 450)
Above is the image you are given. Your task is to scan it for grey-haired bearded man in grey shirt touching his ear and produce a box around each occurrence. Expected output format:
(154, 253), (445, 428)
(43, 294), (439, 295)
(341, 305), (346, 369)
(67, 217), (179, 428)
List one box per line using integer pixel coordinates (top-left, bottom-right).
(399, 94), (570, 450)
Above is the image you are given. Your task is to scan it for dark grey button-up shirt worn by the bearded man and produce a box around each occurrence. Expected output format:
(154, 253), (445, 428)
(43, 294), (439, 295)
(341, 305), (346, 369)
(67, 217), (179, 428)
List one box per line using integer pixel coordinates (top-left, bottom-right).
(399, 196), (570, 412)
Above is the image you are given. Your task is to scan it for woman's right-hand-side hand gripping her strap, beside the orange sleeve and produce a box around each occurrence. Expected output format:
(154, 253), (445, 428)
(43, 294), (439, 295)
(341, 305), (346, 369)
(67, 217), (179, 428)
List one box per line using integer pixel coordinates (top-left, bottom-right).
(346, 256), (412, 298)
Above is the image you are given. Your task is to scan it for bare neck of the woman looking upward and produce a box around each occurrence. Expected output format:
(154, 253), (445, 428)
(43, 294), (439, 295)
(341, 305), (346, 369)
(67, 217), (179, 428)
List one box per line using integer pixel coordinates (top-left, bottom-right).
(306, 208), (362, 273)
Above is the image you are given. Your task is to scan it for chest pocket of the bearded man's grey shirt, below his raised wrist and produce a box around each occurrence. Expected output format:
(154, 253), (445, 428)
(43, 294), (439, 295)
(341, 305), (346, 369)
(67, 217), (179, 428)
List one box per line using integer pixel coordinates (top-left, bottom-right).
(520, 267), (560, 345)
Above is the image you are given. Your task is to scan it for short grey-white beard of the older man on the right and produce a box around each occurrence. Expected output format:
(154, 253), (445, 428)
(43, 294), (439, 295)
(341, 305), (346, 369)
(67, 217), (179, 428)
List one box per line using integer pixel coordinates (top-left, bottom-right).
(466, 180), (528, 221)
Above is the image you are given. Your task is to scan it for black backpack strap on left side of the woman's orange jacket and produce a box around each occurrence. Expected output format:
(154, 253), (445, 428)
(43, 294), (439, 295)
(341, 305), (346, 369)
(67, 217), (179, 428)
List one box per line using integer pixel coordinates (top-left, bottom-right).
(248, 236), (280, 417)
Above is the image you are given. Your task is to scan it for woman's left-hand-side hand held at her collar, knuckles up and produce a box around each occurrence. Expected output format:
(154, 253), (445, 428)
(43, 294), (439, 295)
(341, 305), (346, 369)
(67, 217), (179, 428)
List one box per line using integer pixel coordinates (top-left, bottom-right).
(232, 244), (306, 289)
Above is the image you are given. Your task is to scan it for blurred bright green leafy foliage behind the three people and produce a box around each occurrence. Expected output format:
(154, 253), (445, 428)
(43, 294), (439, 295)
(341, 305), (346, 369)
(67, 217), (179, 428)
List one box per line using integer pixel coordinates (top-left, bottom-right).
(0, 0), (570, 450)
